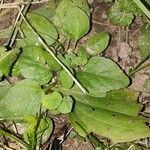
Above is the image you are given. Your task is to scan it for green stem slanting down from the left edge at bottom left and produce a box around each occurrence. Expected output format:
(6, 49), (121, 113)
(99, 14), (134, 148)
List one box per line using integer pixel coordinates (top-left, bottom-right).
(0, 129), (28, 147)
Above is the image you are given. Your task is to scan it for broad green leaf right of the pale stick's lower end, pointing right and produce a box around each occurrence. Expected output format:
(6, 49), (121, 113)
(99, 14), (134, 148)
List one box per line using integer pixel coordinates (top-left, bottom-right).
(77, 57), (130, 97)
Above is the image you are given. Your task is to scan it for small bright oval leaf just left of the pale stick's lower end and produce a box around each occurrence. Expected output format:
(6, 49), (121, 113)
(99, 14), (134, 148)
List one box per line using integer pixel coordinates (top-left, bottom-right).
(59, 70), (73, 89)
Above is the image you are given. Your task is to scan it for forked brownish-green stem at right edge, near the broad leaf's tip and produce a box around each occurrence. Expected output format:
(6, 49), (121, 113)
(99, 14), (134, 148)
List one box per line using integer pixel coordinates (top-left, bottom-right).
(129, 55), (150, 76)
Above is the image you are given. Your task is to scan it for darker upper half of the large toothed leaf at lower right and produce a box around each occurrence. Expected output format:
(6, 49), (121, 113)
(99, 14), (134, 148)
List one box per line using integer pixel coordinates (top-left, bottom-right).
(55, 87), (141, 116)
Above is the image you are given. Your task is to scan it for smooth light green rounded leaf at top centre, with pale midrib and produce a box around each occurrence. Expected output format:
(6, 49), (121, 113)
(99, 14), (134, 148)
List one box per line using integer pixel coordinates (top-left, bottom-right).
(56, 6), (90, 40)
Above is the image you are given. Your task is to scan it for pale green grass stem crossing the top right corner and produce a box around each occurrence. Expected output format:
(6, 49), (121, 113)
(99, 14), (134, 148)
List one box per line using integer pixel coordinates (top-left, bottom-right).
(133, 0), (150, 19)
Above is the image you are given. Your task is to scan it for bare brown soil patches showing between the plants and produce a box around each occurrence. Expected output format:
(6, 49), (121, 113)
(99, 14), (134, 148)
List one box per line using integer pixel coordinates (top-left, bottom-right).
(0, 0), (150, 150)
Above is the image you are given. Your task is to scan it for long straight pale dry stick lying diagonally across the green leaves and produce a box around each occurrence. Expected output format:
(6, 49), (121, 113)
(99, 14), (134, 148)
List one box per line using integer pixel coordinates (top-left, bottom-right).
(21, 13), (87, 93)
